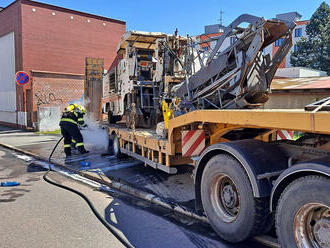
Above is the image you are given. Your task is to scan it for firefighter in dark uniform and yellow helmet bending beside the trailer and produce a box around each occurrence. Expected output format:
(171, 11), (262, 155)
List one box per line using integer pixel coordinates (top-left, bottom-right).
(60, 104), (88, 157)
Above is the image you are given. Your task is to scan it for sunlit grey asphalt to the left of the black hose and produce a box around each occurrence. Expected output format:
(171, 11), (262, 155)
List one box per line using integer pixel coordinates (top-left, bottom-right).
(0, 148), (124, 248)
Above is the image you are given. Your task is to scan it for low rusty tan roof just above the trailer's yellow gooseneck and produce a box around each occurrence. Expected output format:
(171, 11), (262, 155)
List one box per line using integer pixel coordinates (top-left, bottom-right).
(271, 77), (330, 91)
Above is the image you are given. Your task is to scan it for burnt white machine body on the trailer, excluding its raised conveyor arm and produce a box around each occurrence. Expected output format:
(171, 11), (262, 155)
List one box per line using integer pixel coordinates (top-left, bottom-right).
(104, 31), (191, 127)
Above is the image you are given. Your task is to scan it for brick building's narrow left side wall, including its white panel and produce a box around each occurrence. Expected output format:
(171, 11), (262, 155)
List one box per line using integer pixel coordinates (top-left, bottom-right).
(0, 2), (24, 126)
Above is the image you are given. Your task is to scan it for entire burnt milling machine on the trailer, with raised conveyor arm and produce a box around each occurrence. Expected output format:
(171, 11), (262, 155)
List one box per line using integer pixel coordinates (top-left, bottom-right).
(104, 14), (295, 128)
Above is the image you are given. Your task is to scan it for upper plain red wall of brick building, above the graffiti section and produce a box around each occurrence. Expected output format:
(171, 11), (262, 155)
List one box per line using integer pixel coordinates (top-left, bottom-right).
(22, 0), (126, 74)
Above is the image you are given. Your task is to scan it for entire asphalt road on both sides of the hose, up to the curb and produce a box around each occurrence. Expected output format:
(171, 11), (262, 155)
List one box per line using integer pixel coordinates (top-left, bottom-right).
(0, 148), (264, 248)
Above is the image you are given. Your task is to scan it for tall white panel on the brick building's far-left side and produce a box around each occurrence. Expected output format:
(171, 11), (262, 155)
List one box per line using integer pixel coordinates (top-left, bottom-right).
(0, 32), (16, 123)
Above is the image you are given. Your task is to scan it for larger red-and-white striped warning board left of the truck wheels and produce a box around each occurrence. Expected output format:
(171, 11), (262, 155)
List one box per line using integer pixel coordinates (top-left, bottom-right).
(182, 130), (205, 157)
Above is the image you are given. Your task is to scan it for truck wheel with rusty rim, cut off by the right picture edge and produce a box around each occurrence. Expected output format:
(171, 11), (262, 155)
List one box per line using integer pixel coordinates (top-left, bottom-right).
(276, 176), (330, 248)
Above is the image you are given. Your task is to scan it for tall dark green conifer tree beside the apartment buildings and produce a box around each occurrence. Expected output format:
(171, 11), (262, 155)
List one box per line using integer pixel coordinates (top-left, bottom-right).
(291, 2), (330, 75)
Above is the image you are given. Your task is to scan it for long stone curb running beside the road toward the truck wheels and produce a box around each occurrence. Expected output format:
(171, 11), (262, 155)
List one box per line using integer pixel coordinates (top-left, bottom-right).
(0, 142), (280, 248)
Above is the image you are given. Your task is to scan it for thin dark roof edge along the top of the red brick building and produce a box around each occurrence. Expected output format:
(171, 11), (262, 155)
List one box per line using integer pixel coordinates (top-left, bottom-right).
(3, 0), (126, 24)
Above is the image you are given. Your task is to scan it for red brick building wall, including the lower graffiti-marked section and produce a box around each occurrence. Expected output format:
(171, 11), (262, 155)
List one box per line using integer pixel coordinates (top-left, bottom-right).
(18, 0), (126, 128)
